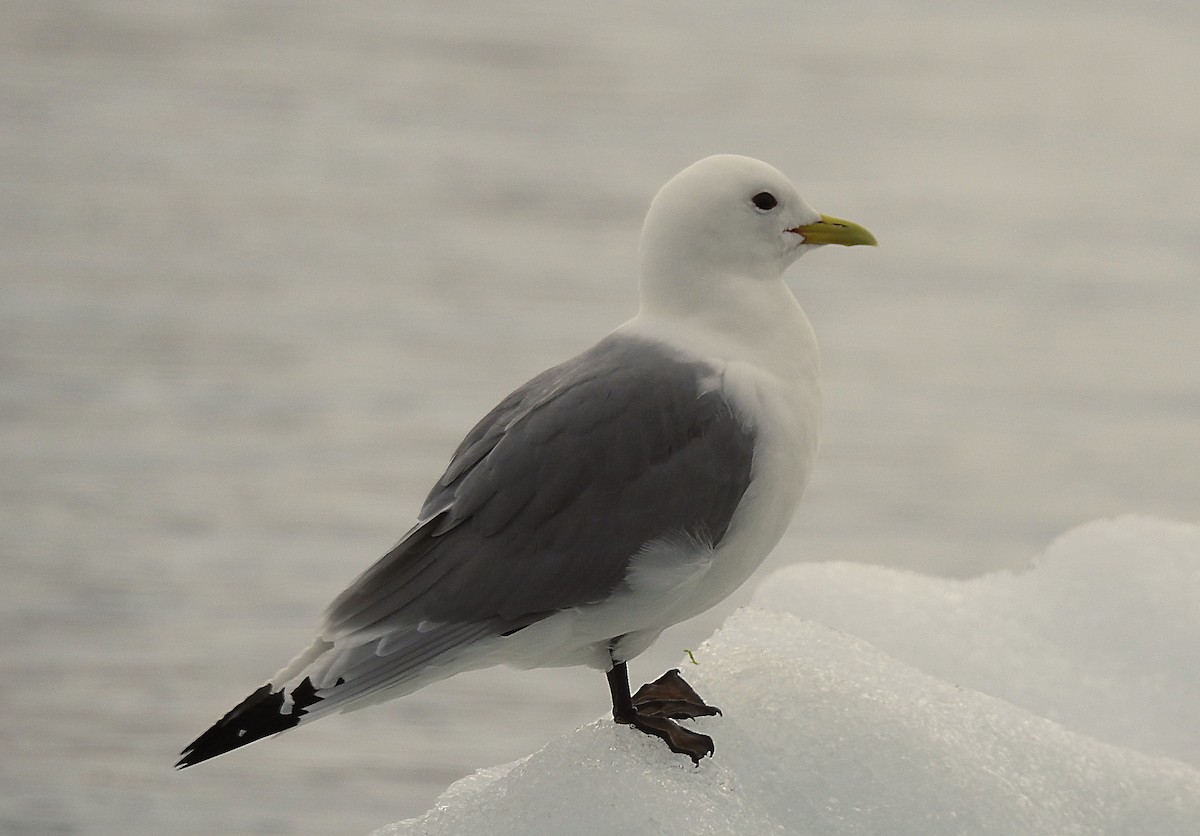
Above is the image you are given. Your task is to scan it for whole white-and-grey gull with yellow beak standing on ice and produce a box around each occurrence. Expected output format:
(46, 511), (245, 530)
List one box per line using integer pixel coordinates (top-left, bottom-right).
(176, 155), (876, 769)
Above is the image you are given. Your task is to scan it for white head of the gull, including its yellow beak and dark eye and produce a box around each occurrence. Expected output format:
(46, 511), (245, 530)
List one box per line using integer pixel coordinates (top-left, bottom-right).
(640, 154), (875, 311)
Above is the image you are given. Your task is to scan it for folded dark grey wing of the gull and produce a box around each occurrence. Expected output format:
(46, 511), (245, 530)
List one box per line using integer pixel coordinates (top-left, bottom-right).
(323, 337), (754, 640)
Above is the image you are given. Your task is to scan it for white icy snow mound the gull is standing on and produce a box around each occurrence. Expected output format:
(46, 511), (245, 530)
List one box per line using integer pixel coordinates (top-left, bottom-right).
(378, 517), (1200, 836)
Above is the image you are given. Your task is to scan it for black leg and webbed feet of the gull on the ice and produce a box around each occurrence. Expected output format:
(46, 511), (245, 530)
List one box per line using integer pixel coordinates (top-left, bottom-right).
(608, 662), (721, 766)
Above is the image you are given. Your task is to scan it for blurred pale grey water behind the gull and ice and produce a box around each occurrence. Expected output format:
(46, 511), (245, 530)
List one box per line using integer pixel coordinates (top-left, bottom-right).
(0, 0), (1200, 834)
